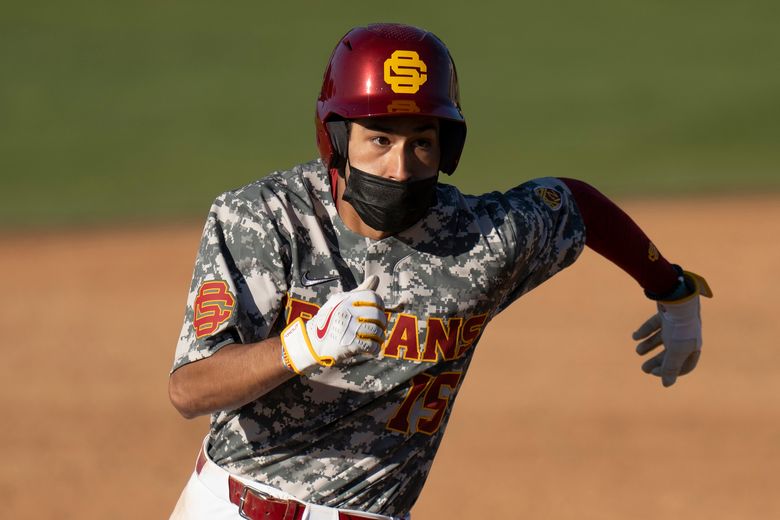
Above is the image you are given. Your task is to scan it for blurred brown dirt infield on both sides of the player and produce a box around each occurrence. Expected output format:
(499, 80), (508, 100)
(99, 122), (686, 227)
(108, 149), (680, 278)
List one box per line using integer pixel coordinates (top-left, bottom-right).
(0, 197), (780, 520)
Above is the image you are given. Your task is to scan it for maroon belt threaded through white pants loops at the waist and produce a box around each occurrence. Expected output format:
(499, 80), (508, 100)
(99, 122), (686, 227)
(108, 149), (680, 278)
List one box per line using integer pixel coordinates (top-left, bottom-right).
(195, 448), (372, 520)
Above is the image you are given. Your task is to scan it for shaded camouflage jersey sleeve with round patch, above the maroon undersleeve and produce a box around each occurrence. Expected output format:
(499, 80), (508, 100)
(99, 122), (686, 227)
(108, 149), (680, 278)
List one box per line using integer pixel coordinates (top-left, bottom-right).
(497, 177), (585, 311)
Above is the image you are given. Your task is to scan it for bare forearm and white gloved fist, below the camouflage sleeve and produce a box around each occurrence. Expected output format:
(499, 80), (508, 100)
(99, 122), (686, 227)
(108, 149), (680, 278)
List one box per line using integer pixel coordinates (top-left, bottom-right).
(168, 275), (387, 419)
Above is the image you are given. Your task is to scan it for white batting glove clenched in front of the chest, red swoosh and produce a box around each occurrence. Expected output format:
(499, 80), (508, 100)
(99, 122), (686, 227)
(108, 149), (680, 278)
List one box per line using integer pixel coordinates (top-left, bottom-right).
(281, 275), (387, 374)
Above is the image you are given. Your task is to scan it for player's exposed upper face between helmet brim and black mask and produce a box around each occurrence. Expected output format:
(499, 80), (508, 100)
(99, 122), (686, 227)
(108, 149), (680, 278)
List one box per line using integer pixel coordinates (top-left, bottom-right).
(349, 116), (441, 182)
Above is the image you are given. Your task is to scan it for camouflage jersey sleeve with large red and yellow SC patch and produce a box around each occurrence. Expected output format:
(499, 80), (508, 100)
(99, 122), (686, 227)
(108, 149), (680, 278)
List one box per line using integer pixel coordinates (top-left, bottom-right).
(171, 192), (289, 371)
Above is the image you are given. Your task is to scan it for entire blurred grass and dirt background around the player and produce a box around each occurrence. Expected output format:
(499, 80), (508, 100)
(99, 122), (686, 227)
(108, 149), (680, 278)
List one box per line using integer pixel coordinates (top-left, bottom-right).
(0, 0), (780, 520)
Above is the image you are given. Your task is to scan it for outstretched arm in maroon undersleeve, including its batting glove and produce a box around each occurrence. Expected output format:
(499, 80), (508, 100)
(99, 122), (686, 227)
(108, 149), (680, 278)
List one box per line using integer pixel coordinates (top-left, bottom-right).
(561, 178), (712, 386)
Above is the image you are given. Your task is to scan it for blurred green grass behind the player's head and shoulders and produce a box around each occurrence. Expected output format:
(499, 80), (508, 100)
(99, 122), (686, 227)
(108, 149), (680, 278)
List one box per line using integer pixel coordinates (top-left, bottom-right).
(0, 0), (780, 229)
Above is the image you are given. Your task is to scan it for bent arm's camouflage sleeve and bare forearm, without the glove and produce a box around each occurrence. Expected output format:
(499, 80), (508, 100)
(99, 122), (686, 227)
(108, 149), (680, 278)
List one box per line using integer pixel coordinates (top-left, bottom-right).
(168, 191), (294, 418)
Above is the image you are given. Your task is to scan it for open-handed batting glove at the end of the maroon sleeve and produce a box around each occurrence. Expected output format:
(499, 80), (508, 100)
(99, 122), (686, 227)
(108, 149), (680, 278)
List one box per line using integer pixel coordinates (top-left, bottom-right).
(633, 271), (712, 387)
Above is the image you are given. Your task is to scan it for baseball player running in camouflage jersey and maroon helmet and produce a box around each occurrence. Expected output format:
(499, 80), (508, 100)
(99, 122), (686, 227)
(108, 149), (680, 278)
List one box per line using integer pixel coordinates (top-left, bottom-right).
(170, 24), (711, 520)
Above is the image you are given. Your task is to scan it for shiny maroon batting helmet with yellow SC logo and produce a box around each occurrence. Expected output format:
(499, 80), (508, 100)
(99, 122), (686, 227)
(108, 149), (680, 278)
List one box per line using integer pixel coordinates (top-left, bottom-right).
(315, 23), (466, 174)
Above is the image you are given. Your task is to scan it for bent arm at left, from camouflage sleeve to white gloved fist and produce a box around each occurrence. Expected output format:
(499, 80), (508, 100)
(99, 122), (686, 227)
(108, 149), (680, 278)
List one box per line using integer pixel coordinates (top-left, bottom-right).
(169, 191), (386, 418)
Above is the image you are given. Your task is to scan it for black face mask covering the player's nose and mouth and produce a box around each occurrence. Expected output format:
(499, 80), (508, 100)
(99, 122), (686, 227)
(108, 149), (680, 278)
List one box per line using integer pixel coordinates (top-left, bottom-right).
(343, 165), (438, 234)
